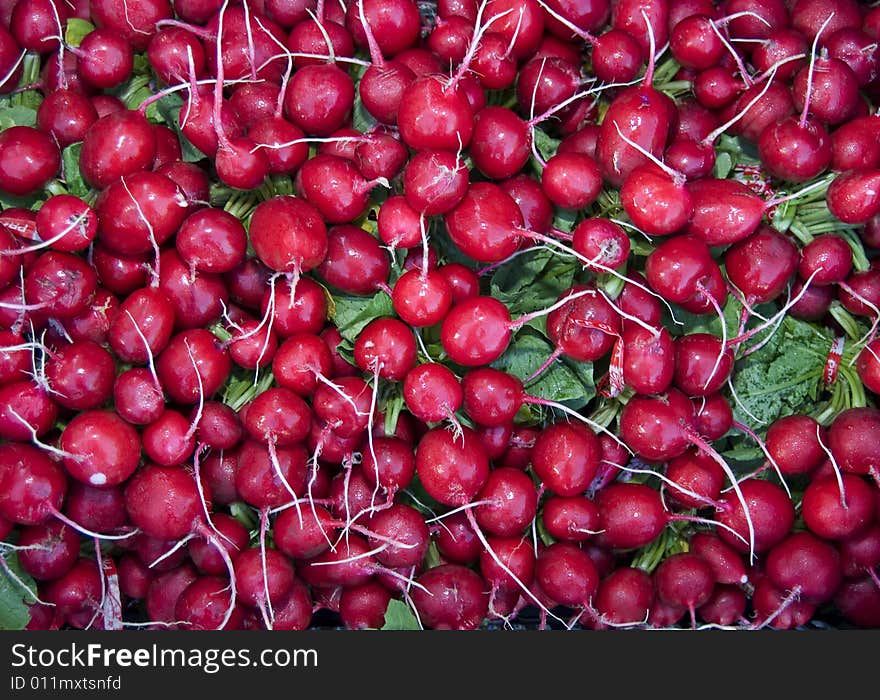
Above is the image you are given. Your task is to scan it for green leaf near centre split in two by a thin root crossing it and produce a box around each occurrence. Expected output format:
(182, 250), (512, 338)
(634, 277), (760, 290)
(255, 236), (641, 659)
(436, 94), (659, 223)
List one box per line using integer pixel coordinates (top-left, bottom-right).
(492, 328), (596, 408)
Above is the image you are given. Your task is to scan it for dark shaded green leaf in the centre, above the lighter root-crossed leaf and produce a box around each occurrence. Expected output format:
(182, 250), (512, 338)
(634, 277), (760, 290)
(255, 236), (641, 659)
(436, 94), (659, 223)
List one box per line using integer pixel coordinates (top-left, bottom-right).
(490, 248), (577, 316)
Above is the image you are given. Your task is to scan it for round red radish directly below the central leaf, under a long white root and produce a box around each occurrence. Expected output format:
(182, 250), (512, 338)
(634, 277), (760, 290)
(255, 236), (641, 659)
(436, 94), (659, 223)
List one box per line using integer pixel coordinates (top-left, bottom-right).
(532, 423), (601, 496)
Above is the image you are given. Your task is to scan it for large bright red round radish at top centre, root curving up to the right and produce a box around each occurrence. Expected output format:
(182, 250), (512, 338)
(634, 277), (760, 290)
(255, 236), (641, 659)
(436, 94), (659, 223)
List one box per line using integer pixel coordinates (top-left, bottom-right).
(397, 76), (474, 153)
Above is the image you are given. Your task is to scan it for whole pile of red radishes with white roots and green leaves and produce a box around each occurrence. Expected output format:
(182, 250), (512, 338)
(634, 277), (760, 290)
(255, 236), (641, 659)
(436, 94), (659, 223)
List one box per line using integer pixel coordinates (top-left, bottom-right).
(0, 0), (880, 629)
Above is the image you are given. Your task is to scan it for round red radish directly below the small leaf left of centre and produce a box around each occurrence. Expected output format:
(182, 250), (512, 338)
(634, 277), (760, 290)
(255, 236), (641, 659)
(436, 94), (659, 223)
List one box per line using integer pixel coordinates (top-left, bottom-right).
(354, 318), (418, 381)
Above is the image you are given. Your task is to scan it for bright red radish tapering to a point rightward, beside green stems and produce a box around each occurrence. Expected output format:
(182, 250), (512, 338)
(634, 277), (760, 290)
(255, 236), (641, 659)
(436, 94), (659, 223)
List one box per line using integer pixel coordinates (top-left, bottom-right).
(684, 179), (766, 246)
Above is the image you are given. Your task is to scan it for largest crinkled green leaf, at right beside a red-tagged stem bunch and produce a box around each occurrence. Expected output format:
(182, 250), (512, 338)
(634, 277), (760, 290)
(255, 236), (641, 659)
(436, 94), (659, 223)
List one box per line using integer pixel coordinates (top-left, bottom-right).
(733, 316), (833, 431)
